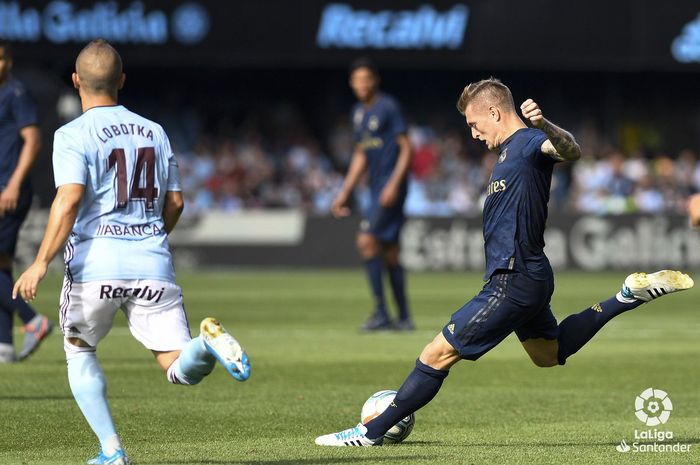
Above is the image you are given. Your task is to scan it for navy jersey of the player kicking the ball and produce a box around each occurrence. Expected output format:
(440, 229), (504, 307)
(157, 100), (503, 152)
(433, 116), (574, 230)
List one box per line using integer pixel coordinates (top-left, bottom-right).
(484, 128), (556, 280)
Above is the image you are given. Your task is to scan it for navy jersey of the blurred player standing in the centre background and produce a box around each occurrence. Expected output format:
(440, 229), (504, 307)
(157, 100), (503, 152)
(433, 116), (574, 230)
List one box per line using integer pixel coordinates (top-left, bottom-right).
(352, 93), (407, 199)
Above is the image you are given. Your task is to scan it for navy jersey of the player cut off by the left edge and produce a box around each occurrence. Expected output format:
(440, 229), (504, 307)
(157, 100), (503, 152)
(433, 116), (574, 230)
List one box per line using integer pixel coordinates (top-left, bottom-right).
(0, 77), (39, 187)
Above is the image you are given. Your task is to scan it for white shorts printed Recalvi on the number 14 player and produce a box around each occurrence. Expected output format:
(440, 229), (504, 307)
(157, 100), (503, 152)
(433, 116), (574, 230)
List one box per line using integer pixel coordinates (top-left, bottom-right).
(59, 277), (191, 352)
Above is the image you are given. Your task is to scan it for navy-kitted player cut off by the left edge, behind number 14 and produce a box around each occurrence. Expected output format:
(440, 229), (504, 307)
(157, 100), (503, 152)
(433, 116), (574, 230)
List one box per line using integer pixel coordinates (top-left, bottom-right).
(0, 42), (53, 363)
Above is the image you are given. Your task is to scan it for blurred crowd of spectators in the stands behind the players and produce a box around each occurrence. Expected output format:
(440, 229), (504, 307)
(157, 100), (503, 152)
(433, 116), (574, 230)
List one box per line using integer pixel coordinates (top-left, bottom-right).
(172, 118), (700, 216)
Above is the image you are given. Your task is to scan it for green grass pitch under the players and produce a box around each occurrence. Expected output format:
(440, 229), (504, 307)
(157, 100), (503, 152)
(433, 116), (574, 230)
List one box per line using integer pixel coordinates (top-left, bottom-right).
(0, 269), (700, 465)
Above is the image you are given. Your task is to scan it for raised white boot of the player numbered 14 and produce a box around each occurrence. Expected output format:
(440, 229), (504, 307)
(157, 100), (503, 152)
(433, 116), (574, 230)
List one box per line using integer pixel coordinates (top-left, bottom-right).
(199, 317), (250, 381)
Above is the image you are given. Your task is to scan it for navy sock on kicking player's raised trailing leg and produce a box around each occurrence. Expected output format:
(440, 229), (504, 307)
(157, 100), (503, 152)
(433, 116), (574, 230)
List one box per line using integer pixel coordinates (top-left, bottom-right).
(559, 297), (644, 365)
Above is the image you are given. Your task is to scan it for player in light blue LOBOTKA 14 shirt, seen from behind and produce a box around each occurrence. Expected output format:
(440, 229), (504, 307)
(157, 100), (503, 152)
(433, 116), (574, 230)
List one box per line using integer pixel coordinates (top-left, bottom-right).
(13, 39), (250, 465)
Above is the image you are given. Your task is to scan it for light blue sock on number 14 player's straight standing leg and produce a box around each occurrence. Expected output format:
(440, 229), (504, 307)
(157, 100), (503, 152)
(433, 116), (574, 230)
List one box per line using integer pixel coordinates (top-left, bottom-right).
(67, 352), (121, 455)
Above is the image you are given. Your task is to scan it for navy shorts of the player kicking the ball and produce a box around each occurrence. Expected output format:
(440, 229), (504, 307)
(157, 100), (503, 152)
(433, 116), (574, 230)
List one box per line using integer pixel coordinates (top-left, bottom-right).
(442, 271), (559, 360)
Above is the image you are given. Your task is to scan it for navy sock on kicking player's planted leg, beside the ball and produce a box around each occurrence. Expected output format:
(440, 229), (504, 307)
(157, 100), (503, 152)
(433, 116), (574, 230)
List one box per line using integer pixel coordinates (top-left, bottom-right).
(365, 360), (450, 439)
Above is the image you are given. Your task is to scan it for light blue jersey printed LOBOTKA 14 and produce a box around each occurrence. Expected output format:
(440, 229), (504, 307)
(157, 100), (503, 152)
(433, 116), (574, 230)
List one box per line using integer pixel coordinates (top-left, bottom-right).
(53, 105), (181, 282)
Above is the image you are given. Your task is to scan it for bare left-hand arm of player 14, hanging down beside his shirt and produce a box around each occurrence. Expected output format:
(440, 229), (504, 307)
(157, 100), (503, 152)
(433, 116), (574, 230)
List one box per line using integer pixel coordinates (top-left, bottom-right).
(12, 184), (85, 301)
